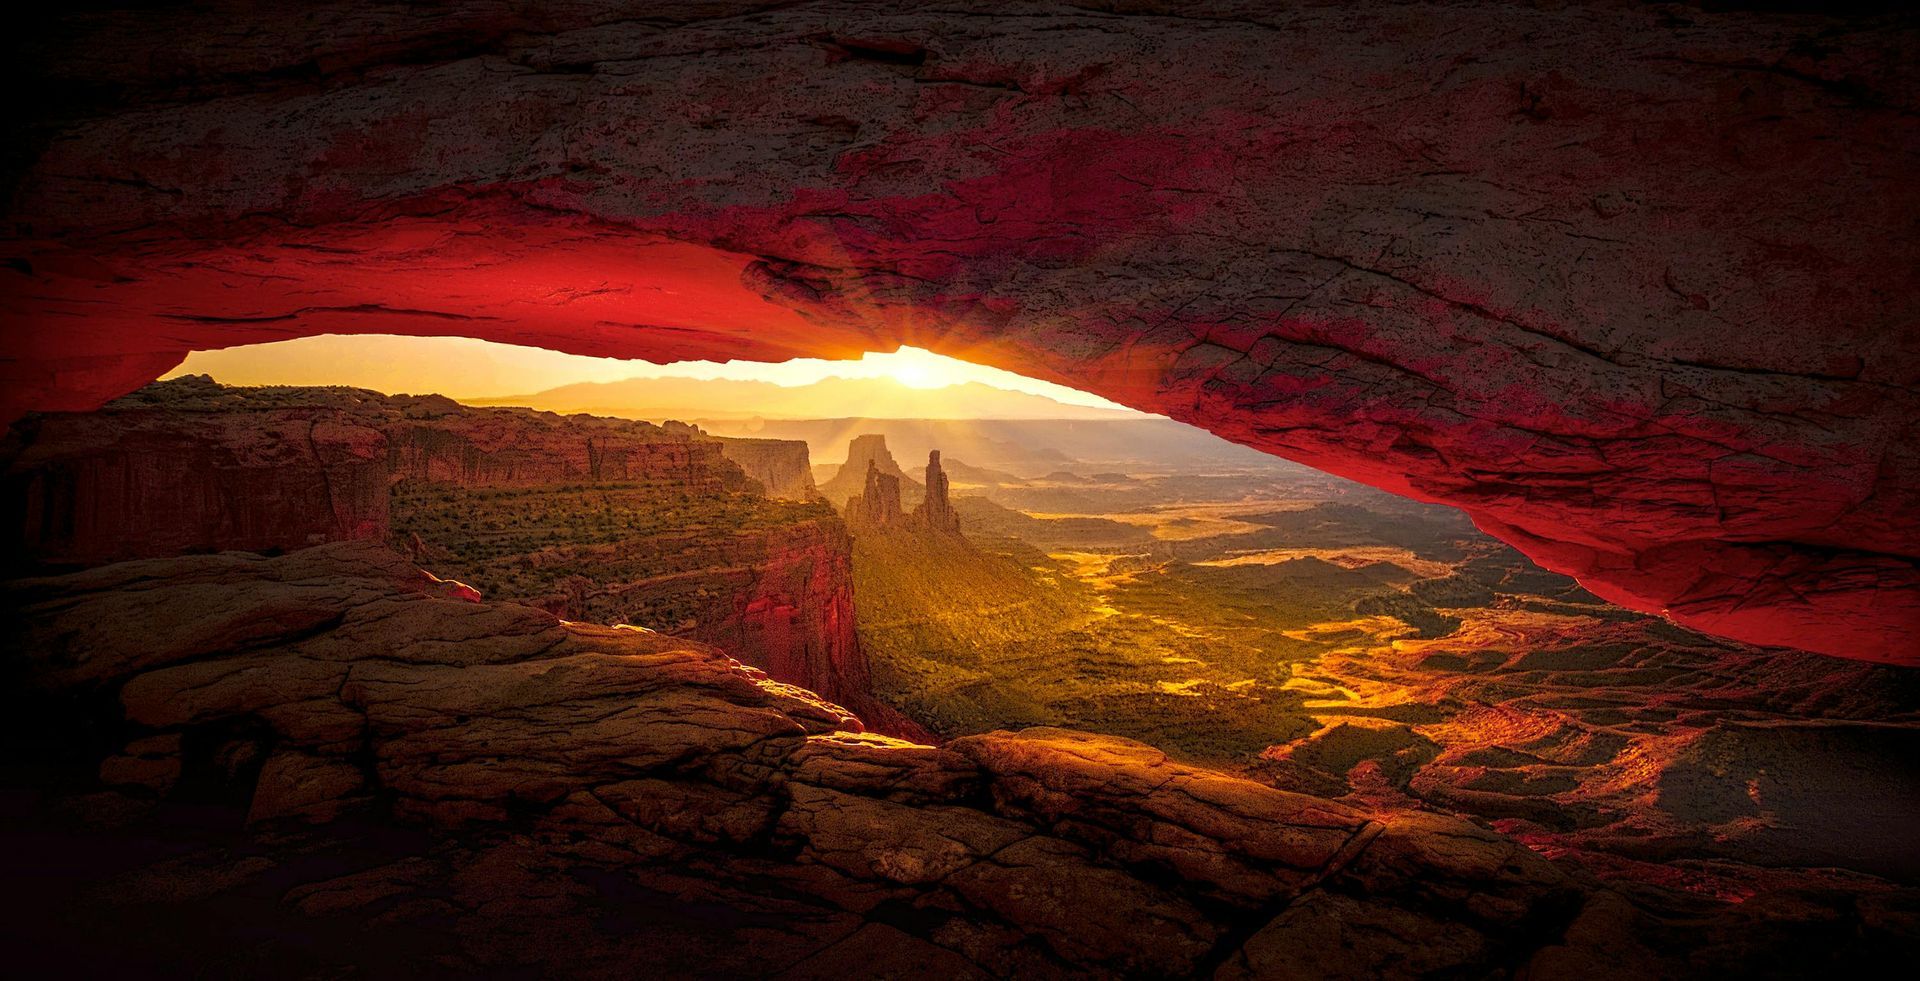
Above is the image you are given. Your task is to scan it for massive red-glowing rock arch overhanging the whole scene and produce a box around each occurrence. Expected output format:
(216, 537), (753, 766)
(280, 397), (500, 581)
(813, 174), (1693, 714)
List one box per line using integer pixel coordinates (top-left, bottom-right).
(0, 4), (1920, 664)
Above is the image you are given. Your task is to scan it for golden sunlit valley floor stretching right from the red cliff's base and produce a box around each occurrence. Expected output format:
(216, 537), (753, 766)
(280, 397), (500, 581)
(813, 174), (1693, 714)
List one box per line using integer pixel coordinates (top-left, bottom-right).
(854, 464), (1920, 898)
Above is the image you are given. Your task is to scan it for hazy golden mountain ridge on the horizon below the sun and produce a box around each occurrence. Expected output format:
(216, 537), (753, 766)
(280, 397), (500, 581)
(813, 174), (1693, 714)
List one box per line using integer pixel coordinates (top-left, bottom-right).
(461, 378), (1152, 420)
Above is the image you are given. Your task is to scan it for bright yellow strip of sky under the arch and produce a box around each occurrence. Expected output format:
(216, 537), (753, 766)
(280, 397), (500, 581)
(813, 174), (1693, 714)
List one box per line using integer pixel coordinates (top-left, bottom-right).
(165, 334), (1123, 409)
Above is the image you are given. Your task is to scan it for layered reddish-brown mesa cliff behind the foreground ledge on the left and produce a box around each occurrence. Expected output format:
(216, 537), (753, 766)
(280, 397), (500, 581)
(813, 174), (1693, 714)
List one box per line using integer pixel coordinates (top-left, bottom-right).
(4, 378), (887, 731)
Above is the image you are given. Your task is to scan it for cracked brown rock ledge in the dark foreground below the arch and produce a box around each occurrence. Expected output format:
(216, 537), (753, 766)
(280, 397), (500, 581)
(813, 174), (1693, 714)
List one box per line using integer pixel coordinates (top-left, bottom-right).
(4, 543), (1914, 977)
